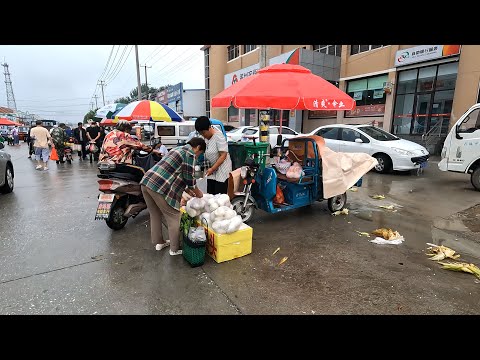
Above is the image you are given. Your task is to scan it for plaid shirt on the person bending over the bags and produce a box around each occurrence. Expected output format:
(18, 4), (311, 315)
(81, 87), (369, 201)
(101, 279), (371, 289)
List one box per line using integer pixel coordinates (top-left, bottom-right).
(140, 144), (196, 210)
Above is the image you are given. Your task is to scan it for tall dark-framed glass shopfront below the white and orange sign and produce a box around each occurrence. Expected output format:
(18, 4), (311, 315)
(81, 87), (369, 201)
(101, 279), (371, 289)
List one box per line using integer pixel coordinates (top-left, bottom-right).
(392, 62), (458, 135)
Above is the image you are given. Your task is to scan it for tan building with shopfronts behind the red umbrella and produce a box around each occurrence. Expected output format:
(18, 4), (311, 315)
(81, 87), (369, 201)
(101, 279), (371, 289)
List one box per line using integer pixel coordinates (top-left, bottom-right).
(202, 45), (480, 153)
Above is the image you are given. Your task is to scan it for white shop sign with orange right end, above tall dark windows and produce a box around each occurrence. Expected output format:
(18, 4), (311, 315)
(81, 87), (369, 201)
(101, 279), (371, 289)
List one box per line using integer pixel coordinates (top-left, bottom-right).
(395, 45), (461, 66)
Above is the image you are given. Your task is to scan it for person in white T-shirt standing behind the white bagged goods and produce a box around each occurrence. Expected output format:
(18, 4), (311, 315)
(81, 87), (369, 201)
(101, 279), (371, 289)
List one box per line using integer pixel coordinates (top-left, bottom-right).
(195, 116), (232, 195)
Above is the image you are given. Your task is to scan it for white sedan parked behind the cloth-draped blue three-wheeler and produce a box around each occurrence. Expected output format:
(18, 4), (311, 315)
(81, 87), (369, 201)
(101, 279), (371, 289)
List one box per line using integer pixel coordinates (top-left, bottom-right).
(309, 124), (430, 173)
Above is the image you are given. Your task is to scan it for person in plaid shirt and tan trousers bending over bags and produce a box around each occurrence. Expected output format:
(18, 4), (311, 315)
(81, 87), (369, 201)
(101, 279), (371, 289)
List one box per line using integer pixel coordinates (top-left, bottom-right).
(140, 138), (206, 256)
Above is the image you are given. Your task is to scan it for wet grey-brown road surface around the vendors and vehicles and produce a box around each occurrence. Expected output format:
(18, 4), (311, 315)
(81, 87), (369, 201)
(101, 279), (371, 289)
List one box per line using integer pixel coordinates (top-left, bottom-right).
(0, 143), (480, 315)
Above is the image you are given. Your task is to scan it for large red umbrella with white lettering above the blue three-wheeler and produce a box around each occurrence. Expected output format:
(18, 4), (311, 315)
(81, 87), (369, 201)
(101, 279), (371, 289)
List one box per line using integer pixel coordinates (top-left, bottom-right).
(211, 64), (355, 131)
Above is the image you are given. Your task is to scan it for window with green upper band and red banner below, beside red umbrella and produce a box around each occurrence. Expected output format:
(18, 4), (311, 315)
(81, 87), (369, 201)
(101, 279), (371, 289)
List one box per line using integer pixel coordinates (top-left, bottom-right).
(345, 74), (388, 117)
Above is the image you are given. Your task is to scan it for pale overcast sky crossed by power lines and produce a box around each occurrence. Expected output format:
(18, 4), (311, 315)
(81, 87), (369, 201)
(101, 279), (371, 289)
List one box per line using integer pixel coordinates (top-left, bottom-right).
(0, 45), (205, 123)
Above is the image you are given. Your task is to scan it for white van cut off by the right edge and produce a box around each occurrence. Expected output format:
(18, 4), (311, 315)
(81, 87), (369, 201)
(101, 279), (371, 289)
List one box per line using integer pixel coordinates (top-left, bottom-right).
(438, 103), (480, 191)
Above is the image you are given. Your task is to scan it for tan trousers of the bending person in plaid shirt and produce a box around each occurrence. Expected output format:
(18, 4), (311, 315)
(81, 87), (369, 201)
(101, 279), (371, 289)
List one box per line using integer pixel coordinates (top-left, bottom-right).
(142, 185), (181, 251)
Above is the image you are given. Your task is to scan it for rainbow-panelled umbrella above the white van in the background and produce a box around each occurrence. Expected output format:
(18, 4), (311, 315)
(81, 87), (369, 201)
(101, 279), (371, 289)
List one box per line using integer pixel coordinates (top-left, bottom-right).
(115, 100), (184, 122)
